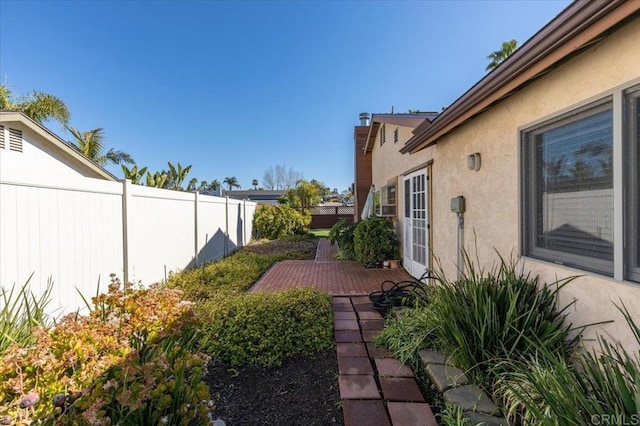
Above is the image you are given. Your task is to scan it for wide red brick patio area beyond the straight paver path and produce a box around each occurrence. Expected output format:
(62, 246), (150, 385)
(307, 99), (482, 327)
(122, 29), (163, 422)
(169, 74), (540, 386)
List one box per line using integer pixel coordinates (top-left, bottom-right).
(250, 238), (412, 296)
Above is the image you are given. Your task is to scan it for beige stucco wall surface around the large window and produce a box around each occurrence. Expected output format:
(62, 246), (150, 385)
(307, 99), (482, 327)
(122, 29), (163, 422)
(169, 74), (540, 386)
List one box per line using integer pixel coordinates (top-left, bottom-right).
(384, 19), (640, 346)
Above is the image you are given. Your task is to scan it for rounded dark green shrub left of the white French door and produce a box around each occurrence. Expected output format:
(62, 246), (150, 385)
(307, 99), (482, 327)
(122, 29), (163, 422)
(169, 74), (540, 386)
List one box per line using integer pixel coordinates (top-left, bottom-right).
(353, 216), (400, 266)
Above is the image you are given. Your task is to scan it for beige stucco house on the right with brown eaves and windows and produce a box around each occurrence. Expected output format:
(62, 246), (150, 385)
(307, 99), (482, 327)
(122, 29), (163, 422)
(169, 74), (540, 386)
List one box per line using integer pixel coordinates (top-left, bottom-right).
(356, 1), (640, 346)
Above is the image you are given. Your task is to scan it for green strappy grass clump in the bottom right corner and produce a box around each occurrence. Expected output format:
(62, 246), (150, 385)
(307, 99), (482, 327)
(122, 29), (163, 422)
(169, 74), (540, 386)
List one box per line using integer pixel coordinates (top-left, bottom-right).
(496, 304), (640, 425)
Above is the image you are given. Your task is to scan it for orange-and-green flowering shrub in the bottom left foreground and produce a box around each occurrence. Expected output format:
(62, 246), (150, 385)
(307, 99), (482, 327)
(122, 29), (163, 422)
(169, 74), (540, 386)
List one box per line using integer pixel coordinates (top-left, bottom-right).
(0, 276), (209, 425)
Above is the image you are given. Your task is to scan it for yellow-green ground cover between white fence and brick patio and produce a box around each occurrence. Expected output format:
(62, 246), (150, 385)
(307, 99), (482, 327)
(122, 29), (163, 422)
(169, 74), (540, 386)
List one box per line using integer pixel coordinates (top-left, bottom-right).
(168, 250), (308, 300)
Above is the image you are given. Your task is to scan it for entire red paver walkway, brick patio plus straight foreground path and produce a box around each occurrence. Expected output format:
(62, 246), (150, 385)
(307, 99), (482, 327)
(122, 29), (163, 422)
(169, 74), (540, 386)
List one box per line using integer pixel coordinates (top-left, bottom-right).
(250, 238), (437, 426)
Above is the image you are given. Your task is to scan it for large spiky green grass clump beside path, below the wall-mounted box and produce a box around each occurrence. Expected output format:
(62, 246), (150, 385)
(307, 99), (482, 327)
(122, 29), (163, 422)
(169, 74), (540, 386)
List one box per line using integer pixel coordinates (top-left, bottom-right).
(431, 255), (584, 392)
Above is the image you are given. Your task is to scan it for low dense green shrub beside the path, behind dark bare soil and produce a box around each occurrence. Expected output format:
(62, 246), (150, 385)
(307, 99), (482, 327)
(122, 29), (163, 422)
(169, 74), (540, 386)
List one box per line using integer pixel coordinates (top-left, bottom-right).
(199, 289), (333, 366)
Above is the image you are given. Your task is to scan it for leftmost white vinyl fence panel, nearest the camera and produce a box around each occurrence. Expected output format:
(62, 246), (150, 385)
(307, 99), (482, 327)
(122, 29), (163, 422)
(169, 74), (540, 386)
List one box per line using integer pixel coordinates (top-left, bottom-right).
(0, 178), (123, 313)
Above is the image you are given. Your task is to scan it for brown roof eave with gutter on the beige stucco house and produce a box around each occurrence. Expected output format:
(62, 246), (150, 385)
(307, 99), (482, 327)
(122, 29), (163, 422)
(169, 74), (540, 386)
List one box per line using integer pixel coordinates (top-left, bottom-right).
(400, 0), (640, 154)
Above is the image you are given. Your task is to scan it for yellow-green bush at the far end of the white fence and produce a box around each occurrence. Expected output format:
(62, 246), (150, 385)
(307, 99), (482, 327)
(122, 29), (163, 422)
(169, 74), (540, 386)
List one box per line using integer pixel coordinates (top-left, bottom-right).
(253, 205), (311, 240)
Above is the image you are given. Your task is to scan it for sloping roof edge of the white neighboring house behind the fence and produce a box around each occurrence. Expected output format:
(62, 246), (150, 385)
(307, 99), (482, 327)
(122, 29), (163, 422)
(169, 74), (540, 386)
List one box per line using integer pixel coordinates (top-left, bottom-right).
(0, 110), (118, 181)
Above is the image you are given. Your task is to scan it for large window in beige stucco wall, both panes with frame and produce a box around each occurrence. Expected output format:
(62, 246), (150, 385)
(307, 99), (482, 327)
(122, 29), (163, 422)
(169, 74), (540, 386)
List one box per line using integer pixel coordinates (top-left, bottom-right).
(521, 86), (640, 282)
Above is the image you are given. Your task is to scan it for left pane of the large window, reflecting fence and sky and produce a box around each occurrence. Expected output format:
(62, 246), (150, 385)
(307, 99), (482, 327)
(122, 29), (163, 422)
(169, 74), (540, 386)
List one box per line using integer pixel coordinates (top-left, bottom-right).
(523, 101), (614, 274)
